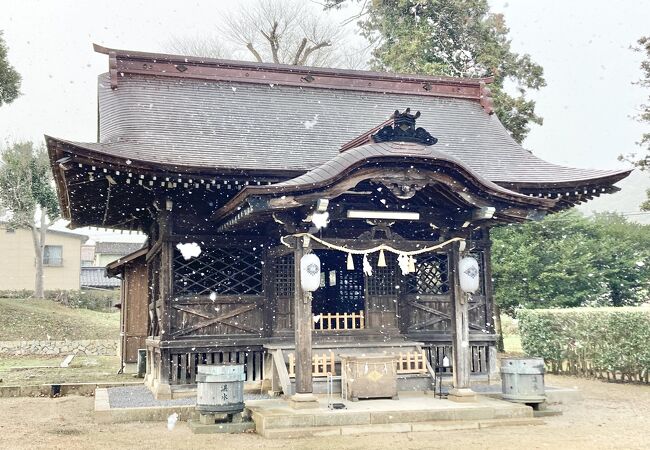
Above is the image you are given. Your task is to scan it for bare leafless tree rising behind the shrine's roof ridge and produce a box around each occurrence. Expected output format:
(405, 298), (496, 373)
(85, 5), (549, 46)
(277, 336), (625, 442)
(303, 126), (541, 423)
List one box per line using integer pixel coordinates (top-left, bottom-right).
(166, 0), (370, 69)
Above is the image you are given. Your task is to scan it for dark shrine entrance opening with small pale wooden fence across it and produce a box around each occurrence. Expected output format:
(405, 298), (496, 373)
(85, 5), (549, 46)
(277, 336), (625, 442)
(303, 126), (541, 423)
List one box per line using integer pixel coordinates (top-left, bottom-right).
(312, 250), (366, 330)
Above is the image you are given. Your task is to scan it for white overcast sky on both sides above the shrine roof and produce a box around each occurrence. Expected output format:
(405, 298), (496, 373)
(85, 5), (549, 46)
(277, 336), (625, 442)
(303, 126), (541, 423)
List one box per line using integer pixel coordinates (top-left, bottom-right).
(0, 0), (650, 229)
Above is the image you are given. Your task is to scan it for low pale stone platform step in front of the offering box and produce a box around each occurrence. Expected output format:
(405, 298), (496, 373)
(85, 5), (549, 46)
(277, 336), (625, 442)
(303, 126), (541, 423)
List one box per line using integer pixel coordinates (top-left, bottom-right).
(246, 392), (543, 438)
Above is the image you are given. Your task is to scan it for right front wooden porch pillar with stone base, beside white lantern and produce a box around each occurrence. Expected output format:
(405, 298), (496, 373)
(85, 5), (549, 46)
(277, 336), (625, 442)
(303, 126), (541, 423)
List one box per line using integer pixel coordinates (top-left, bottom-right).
(449, 242), (476, 402)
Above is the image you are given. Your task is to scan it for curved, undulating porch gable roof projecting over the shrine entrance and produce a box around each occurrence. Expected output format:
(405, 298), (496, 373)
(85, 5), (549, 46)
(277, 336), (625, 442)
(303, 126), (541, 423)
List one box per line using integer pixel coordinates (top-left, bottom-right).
(213, 142), (559, 229)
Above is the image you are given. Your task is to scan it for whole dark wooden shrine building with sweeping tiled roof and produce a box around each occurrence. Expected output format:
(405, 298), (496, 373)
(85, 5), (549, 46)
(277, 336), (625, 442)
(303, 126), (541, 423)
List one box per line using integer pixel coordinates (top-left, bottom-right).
(46, 46), (629, 402)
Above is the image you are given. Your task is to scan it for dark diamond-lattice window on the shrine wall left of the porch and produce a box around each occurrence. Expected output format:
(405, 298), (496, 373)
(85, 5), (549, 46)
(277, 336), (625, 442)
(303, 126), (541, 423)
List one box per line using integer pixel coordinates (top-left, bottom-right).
(174, 247), (262, 295)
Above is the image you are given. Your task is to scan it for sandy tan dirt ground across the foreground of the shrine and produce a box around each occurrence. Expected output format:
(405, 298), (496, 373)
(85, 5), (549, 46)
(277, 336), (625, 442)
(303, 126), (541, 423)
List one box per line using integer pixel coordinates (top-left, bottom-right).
(0, 376), (650, 450)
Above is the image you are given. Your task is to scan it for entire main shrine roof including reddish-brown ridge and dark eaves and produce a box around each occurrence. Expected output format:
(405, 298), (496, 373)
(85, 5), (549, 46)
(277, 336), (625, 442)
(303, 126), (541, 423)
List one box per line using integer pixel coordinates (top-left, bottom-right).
(46, 46), (630, 226)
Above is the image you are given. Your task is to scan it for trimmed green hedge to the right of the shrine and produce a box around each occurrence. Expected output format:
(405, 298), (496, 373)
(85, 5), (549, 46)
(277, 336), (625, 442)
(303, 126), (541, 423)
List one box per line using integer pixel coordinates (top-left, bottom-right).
(517, 307), (650, 383)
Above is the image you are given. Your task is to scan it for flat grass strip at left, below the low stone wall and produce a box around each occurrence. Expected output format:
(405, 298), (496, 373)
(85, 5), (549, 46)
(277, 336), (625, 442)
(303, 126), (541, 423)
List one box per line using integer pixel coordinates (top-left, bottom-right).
(0, 355), (135, 385)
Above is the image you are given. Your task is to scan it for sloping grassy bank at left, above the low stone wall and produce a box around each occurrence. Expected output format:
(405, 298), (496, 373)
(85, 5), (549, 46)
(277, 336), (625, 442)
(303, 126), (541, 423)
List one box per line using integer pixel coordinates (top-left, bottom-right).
(0, 298), (120, 341)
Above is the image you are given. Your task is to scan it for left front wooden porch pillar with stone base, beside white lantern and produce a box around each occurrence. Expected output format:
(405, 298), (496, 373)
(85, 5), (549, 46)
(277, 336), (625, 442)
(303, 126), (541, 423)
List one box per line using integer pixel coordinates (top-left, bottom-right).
(290, 239), (318, 409)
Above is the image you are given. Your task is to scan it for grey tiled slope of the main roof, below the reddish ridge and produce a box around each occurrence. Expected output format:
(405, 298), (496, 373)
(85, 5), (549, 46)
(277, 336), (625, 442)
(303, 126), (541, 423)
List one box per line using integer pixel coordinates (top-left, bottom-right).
(49, 75), (623, 185)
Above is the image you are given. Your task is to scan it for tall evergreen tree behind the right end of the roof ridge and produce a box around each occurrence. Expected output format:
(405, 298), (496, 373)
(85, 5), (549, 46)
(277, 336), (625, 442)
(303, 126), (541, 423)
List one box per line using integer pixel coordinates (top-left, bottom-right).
(326, 0), (546, 142)
